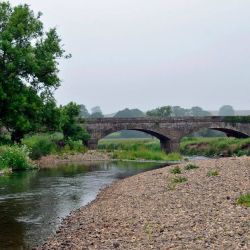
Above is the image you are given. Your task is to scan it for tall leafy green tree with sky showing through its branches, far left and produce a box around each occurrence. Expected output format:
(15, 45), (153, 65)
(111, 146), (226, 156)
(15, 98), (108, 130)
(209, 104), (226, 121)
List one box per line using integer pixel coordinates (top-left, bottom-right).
(0, 2), (69, 142)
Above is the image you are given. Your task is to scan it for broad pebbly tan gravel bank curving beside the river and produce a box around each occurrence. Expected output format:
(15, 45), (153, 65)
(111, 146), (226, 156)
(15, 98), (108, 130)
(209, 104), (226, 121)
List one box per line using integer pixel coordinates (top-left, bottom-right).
(40, 157), (250, 250)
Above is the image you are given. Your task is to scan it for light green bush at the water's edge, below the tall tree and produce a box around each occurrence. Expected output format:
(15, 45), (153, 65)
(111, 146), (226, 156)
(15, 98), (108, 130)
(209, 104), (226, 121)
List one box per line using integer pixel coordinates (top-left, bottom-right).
(0, 145), (33, 170)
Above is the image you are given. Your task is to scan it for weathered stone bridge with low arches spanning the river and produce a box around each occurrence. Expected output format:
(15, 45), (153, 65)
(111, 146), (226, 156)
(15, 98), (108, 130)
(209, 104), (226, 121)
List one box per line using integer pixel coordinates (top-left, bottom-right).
(84, 116), (250, 152)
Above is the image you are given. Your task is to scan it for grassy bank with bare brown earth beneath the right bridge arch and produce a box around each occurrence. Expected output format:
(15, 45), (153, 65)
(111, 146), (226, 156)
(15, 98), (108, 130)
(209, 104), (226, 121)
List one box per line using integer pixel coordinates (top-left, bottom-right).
(181, 137), (250, 157)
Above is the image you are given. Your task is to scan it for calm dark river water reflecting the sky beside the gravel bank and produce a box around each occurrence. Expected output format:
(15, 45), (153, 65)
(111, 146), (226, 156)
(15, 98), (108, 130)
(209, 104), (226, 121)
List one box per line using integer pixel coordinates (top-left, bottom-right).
(0, 162), (168, 250)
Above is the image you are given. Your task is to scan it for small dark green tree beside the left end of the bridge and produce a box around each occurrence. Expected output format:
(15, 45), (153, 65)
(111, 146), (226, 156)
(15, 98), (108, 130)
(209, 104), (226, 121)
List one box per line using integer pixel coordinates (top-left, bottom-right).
(60, 102), (89, 142)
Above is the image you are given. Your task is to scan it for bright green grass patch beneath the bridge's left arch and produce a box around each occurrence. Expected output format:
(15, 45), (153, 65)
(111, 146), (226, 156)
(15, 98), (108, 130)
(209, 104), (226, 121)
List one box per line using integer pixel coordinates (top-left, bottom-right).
(98, 139), (181, 161)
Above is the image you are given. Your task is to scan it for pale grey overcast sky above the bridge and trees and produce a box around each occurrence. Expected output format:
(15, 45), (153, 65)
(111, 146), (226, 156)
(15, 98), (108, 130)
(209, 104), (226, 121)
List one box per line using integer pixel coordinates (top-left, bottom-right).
(10, 0), (250, 113)
